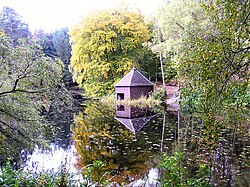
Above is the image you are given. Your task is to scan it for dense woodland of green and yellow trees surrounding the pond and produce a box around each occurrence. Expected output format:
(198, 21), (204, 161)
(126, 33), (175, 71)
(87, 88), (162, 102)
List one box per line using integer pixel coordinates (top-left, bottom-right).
(0, 0), (250, 186)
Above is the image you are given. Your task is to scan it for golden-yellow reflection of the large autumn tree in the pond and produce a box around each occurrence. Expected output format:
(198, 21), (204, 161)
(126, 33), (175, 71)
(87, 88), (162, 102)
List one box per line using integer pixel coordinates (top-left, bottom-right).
(73, 103), (172, 183)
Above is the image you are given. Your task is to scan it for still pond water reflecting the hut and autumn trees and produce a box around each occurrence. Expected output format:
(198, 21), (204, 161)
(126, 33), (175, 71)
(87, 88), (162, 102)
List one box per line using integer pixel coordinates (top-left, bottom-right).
(23, 102), (250, 186)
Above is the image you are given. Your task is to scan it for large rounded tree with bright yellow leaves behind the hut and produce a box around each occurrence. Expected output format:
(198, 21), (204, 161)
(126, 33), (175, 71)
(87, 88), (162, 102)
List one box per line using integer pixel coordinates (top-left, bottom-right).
(70, 8), (150, 97)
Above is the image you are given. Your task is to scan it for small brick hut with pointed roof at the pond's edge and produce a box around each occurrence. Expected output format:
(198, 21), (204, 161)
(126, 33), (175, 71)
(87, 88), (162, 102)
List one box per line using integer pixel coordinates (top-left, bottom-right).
(115, 67), (153, 100)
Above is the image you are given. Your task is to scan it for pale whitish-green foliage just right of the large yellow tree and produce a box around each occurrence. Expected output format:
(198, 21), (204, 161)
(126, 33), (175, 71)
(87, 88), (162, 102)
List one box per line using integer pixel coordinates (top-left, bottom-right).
(152, 0), (207, 80)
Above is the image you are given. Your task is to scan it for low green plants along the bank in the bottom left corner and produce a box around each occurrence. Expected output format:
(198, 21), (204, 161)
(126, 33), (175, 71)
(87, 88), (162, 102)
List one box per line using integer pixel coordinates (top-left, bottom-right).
(0, 160), (108, 187)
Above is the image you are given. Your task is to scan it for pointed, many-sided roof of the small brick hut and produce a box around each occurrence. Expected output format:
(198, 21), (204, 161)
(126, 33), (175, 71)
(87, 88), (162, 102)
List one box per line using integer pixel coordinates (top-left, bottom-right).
(115, 67), (153, 87)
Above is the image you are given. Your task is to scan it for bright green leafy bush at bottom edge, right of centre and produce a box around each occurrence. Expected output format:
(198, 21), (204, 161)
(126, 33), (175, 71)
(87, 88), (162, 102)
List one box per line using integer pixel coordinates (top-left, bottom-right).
(159, 152), (210, 187)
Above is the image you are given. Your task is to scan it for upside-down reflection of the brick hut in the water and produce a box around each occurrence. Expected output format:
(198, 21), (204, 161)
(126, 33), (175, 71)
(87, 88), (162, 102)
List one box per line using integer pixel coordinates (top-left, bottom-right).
(115, 105), (155, 133)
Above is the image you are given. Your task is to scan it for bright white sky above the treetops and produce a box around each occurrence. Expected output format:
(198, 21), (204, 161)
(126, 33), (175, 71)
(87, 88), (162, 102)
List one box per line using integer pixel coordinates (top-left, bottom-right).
(0, 0), (161, 32)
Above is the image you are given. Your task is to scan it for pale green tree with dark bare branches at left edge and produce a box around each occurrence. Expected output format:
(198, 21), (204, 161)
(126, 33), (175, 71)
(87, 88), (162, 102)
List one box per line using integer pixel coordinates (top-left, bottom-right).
(0, 35), (68, 156)
